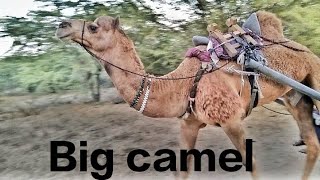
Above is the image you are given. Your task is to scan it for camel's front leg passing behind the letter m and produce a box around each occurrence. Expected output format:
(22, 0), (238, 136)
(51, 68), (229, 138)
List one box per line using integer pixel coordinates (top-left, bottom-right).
(176, 115), (206, 179)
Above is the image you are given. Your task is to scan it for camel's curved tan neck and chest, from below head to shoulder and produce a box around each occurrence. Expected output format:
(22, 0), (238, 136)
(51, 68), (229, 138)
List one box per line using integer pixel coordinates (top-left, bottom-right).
(96, 33), (199, 117)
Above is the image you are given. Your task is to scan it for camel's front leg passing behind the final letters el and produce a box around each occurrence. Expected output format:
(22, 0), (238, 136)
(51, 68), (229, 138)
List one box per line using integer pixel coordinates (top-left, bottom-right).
(221, 114), (258, 179)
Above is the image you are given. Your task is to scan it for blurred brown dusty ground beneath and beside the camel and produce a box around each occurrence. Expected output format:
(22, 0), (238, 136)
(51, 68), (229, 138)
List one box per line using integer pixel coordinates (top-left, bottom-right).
(0, 95), (320, 179)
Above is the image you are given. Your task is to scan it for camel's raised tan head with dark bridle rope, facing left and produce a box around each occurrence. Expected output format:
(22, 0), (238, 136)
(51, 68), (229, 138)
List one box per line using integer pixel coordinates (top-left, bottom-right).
(56, 16), (122, 53)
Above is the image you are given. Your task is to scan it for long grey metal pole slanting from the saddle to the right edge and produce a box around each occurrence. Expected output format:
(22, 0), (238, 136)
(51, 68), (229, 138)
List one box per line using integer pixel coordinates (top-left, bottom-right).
(245, 59), (320, 101)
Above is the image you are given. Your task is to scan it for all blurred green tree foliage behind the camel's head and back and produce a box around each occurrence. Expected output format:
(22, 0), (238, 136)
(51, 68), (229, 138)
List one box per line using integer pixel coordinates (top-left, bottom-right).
(0, 0), (320, 93)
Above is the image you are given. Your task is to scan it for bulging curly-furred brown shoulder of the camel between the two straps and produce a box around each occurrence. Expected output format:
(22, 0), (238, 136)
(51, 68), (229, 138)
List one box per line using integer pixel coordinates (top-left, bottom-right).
(194, 73), (243, 125)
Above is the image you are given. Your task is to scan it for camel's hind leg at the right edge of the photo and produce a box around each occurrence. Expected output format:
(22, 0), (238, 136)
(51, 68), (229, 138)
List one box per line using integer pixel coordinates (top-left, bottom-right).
(285, 92), (320, 180)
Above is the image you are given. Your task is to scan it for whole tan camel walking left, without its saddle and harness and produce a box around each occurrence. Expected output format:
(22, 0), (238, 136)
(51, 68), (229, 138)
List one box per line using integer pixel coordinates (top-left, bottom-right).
(56, 11), (320, 180)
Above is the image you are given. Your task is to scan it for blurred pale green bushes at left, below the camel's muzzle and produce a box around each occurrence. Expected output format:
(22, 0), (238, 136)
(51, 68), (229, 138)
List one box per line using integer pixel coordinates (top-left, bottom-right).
(0, 47), (94, 93)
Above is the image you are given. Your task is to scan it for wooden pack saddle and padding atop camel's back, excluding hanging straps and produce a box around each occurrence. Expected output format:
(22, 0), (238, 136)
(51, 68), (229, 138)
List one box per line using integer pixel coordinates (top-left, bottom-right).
(186, 13), (262, 62)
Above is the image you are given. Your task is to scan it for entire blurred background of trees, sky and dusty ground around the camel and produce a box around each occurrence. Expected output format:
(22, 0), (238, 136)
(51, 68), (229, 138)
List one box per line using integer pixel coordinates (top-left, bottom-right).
(0, 0), (320, 180)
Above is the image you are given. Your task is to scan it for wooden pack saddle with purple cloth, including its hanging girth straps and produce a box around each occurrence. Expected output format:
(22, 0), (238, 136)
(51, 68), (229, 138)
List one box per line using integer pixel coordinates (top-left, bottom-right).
(182, 13), (265, 119)
